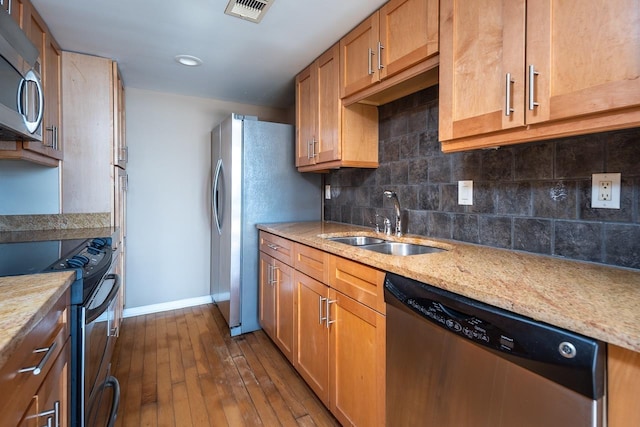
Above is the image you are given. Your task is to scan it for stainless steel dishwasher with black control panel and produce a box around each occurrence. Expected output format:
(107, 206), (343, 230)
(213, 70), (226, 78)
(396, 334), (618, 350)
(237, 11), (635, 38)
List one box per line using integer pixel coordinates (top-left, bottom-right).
(384, 273), (606, 427)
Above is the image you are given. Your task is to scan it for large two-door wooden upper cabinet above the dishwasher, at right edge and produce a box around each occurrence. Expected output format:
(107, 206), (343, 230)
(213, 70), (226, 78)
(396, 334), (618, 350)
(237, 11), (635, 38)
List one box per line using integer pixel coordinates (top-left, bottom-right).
(439, 0), (640, 151)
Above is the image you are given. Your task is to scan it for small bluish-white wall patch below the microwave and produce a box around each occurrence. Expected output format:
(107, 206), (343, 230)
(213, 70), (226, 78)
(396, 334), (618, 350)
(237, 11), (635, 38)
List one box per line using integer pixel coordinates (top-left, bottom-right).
(0, 160), (60, 215)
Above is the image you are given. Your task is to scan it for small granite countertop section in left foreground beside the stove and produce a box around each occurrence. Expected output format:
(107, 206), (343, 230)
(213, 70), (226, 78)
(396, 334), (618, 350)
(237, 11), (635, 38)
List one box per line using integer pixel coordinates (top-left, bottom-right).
(0, 270), (76, 366)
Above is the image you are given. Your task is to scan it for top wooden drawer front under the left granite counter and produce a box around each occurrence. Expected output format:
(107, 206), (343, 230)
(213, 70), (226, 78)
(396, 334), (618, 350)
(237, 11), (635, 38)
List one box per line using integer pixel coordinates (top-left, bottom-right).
(0, 291), (70, 427)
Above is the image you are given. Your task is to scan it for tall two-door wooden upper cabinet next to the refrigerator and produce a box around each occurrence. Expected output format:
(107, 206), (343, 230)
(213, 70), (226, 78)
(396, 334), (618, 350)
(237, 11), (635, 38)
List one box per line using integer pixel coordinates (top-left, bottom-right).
(296, 44), (378, 172)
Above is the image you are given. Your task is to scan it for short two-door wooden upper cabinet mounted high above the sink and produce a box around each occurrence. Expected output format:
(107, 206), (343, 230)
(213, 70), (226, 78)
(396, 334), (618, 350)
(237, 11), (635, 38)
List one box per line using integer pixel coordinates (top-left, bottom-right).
(340, 0), (438, 98)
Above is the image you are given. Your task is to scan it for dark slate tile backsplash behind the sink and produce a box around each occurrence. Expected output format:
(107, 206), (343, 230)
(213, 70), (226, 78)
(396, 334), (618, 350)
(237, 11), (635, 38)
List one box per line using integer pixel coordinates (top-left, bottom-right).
(325, 87), (640, 269)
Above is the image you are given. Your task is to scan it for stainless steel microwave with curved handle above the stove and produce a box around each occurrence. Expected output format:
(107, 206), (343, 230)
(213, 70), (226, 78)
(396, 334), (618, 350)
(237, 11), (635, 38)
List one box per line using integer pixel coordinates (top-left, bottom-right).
(0, 10), (44, 141)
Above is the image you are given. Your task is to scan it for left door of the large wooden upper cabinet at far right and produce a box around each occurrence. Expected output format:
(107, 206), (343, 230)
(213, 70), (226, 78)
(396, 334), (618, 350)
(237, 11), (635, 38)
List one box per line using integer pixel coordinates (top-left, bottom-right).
(439, 0), (525, 141)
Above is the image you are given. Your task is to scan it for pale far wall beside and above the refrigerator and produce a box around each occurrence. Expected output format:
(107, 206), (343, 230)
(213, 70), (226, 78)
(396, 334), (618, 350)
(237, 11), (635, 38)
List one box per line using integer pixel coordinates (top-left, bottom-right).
(126, 88), (290, 309)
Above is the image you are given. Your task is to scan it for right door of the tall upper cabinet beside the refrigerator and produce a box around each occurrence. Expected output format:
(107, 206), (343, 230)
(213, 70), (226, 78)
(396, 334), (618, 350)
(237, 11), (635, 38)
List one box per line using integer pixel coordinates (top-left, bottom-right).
(316, 44), (342, 163)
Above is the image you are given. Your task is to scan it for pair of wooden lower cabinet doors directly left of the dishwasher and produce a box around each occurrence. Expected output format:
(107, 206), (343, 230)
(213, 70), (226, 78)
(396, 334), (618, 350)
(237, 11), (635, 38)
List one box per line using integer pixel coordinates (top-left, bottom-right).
(294, 271), (385, 426)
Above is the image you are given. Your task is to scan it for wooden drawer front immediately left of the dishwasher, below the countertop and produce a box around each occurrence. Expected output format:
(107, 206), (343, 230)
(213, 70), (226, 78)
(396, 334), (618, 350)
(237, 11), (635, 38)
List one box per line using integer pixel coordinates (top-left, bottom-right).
(329, 255), (386, 314)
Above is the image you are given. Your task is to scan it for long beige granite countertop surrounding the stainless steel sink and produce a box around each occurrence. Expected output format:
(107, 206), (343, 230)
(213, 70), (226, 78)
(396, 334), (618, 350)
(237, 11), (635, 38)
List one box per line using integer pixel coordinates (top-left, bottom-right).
(258, 222), (640, 351)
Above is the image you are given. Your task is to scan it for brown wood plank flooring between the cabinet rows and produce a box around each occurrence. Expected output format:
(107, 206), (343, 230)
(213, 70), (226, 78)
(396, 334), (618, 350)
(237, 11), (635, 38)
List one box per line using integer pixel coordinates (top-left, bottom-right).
(112, 304), (340, 427)
